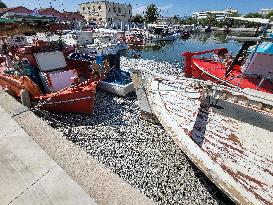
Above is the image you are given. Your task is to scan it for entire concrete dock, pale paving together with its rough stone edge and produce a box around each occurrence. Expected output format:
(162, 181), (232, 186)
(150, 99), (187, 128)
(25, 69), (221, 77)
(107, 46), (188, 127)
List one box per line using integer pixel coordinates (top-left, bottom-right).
(0, 90), (154, 205)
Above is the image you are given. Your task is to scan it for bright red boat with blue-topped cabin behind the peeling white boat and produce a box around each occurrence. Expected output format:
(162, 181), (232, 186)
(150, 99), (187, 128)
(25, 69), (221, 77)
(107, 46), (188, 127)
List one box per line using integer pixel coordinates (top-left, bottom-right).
(183, 17), (273, 93)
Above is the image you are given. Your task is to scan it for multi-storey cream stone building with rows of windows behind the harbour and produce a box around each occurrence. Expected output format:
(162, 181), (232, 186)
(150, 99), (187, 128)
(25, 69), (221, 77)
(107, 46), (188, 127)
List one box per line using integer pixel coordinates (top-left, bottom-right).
(80, 1), (132, 29)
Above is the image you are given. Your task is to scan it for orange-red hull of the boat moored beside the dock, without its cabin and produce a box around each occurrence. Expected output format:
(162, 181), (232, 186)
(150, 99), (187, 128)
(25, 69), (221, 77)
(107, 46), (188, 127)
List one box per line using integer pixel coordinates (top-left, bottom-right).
(0, 72), (97, 114)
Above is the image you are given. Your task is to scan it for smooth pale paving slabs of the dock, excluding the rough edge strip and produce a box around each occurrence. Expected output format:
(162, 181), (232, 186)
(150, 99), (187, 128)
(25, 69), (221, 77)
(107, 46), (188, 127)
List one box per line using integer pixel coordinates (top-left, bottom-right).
(0, 106), (96, 205)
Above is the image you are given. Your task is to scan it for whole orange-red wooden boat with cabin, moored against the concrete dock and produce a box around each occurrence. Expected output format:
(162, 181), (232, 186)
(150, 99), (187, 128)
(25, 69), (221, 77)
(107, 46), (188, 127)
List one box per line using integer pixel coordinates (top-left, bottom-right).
(0, 48), (109, 114)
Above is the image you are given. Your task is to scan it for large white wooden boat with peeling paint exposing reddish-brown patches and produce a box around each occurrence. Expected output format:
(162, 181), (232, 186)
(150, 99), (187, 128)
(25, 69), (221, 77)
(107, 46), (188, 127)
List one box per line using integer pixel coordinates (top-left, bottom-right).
(147, 77), (273, 205)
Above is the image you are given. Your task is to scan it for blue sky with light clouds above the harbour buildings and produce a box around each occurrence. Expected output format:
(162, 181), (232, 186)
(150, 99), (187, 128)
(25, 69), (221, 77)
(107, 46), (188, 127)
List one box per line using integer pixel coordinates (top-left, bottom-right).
(2, 0), (273, 17)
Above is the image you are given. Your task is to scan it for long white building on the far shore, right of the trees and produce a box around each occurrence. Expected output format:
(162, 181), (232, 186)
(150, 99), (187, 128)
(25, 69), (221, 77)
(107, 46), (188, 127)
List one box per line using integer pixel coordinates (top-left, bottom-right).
(192, 8), (239, 21)
